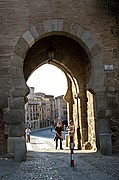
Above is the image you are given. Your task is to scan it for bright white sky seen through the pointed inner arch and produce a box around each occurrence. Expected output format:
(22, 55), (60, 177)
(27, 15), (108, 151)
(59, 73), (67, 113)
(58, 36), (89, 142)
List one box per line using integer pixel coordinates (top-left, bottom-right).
(27, 64), (67, 97)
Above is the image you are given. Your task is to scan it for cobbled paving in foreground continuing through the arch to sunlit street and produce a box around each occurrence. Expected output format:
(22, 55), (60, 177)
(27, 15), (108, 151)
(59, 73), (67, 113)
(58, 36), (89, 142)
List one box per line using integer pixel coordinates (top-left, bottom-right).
(0, 130), (119, 180)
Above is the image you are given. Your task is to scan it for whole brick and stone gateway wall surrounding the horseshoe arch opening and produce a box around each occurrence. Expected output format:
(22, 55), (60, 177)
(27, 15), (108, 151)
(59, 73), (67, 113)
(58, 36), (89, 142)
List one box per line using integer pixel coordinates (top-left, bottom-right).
(0, 0), (119, 161)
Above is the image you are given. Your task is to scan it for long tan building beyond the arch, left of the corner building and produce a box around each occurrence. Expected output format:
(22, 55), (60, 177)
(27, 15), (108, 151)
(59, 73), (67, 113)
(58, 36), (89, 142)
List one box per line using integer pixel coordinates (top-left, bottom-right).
(25, 87), (61, 129)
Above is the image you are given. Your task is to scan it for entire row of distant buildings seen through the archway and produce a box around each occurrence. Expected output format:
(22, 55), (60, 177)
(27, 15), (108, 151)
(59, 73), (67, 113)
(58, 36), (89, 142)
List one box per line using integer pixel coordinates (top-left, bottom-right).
(25, 87), (67, 130)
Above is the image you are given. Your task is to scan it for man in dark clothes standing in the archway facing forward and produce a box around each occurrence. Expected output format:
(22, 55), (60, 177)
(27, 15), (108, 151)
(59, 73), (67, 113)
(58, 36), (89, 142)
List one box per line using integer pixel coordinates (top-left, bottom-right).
(55, 122), (63, 149)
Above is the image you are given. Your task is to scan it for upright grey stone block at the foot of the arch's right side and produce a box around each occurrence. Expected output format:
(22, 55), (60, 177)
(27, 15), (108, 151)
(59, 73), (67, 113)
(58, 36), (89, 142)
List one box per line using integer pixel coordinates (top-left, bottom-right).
(100, 133), (112, 156)
